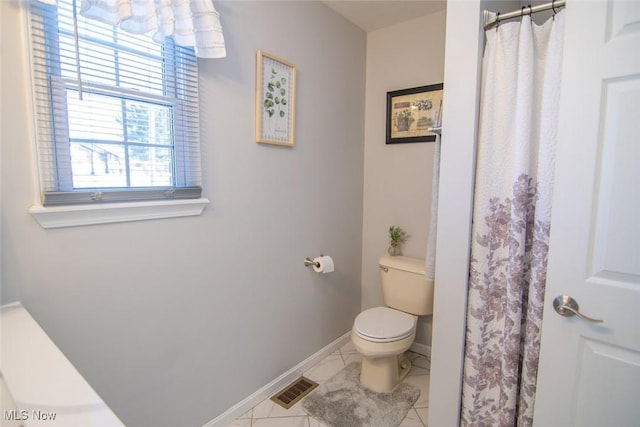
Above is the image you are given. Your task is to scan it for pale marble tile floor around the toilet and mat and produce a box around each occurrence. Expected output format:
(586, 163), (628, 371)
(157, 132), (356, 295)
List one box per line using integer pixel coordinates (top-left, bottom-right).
(229, 341), (430, 427)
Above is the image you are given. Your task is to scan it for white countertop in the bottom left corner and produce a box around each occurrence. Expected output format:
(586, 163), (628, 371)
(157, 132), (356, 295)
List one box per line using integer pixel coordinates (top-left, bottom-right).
(0, 304), (124, 427)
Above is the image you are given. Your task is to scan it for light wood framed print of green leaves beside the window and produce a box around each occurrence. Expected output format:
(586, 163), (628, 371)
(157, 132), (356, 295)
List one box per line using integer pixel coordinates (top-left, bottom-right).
(256, 50), (296, 147)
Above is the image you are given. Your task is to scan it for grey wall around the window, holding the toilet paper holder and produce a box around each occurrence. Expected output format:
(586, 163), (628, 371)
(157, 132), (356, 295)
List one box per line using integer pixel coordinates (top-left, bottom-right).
(0, 1), (366, 426)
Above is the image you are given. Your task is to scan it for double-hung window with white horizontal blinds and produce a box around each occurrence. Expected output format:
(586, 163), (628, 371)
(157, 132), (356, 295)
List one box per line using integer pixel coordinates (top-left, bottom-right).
(30, 0), (201, 207)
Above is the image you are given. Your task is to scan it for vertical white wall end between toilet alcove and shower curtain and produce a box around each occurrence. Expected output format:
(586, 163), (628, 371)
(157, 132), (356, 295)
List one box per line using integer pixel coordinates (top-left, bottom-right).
(428, 0), (482, 426)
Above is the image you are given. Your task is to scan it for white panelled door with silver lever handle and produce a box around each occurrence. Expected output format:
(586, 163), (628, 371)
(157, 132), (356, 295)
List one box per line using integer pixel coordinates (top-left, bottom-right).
(534, 0), (640, 427)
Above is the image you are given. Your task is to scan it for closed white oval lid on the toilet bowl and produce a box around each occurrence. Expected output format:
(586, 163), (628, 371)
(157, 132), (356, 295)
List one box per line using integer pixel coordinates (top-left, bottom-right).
(353, 307), (416, 342)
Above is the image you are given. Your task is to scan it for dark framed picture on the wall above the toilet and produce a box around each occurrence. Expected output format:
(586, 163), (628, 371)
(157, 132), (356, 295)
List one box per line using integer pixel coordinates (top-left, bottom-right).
(387, 83), (444, 144)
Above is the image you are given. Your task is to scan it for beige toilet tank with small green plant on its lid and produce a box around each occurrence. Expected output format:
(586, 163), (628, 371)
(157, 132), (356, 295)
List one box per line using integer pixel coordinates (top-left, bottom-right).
(380, 256), (433, 316)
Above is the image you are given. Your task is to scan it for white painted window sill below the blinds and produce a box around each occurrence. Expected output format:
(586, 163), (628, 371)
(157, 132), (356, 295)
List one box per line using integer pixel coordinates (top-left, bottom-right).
(29, 198), (209, 229)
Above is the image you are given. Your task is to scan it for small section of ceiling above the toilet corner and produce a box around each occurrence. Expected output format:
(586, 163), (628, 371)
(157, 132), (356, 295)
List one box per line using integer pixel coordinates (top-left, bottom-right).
(323, 0), (447, 32)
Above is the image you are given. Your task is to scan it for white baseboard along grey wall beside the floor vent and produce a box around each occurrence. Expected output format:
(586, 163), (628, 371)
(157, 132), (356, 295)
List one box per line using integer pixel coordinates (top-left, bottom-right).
(203, 331), (351, 427)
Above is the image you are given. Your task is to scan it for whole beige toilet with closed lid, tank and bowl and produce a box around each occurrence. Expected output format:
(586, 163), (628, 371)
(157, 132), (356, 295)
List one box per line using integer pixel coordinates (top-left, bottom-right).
(351, 256), (433, 393)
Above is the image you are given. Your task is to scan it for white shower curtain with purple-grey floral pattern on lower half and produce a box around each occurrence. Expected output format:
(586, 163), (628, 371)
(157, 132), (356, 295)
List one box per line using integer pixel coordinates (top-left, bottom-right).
(461, 12), (564, 427)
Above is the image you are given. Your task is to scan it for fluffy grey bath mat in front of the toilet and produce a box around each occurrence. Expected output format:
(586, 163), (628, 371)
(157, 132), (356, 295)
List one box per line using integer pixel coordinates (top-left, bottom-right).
(302, 362), (420, 427)
